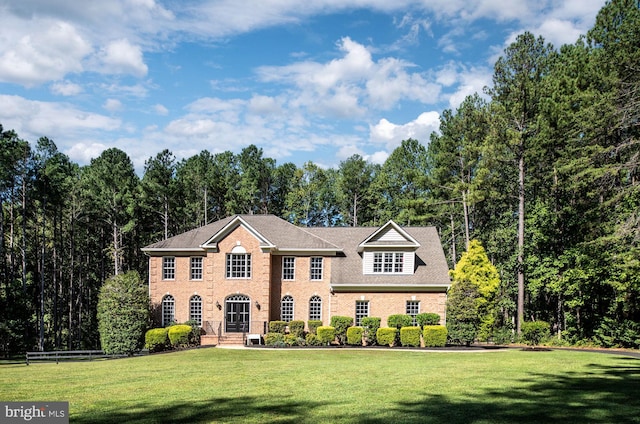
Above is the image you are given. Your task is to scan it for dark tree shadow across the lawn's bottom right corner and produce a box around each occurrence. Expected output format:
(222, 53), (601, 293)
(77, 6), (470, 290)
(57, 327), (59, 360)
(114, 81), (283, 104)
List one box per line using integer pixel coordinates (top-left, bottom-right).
(359, 358), (640, 424)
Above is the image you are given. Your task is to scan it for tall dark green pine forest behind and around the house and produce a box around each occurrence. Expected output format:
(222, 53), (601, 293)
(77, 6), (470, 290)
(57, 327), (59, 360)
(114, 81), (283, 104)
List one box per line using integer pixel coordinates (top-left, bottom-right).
(0, 0), (640, 354)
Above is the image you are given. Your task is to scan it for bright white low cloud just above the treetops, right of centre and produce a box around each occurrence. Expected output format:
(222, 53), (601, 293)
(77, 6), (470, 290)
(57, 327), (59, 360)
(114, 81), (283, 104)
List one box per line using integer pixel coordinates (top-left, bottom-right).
(369, 112), (440, 151)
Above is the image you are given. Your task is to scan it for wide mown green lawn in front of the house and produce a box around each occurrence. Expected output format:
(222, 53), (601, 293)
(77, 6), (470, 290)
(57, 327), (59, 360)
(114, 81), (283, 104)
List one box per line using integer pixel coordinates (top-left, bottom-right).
(0, 349), (640, 424)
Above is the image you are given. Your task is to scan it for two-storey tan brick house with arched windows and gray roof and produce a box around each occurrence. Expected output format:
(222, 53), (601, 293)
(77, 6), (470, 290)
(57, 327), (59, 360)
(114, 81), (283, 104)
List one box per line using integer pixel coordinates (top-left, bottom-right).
(143, 215), (450, 344)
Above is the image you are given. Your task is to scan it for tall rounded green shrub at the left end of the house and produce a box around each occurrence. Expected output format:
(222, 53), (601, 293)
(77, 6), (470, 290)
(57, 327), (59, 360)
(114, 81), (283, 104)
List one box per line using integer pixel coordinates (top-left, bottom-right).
(97, 271), (149, 355)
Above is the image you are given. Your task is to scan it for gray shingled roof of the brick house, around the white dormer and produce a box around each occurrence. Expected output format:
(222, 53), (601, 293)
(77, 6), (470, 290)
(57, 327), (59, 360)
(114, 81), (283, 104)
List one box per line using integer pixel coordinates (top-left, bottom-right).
(143, 215), (450, 289)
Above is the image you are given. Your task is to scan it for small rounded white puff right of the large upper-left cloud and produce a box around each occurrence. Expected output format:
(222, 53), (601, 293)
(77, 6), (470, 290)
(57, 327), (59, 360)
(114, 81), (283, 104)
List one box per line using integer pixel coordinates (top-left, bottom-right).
(96, 39), (149, 77)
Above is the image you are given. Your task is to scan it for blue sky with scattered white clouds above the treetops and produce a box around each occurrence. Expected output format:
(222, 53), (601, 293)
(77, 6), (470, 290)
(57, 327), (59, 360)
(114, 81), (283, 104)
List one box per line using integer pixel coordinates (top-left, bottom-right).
(0, 0), (605, 173)
